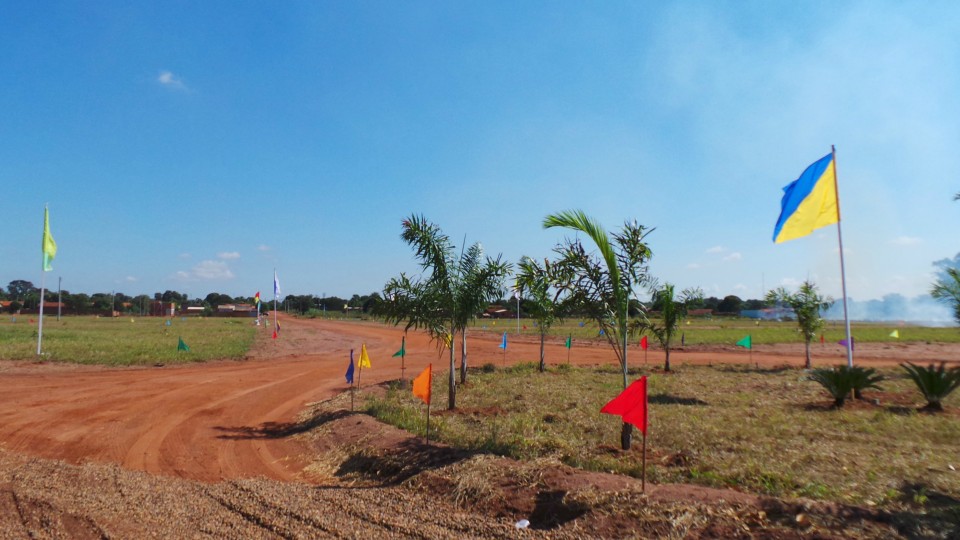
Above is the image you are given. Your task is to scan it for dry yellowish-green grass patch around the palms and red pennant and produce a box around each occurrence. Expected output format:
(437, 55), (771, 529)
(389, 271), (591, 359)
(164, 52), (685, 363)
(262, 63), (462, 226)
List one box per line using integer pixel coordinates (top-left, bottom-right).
(368, 364), (960, 523)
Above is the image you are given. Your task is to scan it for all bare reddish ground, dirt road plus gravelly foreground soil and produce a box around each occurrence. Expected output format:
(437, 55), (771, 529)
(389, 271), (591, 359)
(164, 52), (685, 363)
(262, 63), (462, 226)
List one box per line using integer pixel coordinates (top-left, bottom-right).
(0, 316), (960, 538)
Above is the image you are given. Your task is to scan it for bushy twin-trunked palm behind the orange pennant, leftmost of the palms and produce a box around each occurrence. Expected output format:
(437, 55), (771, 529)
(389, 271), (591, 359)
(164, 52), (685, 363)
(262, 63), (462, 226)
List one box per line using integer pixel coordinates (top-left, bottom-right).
(380, 215), (511, 409)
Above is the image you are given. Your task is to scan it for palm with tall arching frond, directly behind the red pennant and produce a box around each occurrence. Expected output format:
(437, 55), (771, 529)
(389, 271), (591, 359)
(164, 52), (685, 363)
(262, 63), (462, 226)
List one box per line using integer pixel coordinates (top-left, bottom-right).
(543, 210), (653, 450)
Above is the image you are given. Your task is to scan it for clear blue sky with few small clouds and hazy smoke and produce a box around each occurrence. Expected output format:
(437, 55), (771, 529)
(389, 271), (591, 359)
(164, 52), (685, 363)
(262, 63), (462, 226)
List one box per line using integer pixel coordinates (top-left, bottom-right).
(0, 1), (960, 312)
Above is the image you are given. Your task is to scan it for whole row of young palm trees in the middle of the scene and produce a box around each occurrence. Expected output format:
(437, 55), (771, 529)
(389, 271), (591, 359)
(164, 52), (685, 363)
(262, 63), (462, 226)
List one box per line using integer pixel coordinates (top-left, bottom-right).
(381, 210), (702, 449)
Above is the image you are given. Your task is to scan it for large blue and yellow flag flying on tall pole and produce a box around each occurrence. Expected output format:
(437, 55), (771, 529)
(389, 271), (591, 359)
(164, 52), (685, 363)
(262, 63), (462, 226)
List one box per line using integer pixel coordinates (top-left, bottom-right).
(773, 153), (840, 244)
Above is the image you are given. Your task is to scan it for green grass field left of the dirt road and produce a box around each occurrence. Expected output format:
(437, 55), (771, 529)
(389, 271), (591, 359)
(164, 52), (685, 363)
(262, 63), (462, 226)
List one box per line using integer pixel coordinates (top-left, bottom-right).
(0, 316), (256, 366)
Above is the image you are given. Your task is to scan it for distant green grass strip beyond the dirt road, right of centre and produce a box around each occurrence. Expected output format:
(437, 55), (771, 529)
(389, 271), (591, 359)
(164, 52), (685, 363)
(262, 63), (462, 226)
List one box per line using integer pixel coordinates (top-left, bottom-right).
(471, 317), (960, 345)
